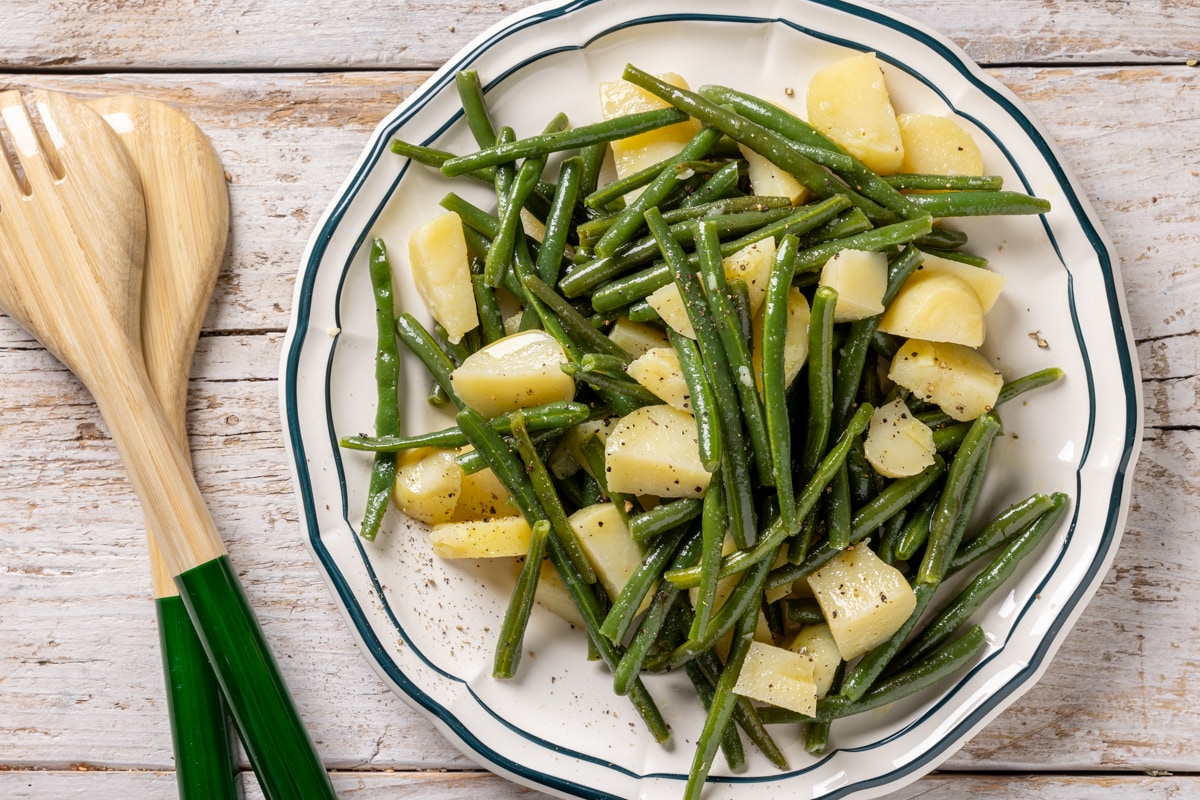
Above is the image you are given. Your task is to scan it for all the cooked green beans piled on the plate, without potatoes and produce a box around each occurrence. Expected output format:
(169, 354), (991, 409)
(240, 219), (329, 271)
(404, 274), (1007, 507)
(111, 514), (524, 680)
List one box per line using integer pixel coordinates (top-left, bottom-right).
(342, 66), (1068, 798)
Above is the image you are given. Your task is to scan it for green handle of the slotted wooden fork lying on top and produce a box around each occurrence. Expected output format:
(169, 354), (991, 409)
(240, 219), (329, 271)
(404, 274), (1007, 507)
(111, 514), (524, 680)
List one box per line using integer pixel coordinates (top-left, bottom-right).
(175, 555), (335, 800)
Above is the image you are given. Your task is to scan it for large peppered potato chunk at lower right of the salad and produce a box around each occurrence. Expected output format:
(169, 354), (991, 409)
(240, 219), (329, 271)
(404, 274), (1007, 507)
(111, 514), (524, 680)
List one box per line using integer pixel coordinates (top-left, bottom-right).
(809, 545), (917, 661)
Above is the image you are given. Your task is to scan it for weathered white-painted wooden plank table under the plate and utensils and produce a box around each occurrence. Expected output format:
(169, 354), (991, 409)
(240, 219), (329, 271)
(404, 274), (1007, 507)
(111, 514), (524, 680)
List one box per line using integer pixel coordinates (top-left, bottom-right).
(0, 0), (1200, 800)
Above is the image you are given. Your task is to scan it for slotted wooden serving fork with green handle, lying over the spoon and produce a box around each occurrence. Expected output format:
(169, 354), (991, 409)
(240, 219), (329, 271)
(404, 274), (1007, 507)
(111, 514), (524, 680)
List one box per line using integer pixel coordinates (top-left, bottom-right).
(0, 91), (334, 800)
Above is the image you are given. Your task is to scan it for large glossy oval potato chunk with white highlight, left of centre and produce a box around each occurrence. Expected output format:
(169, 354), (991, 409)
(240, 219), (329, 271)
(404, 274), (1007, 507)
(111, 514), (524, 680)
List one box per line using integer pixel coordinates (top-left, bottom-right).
(450, 328), (575, 417)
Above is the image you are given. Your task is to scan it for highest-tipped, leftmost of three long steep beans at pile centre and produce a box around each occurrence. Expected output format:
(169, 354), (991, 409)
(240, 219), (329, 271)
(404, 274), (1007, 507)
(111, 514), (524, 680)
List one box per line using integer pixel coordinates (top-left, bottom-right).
(646, 203), (757, 547)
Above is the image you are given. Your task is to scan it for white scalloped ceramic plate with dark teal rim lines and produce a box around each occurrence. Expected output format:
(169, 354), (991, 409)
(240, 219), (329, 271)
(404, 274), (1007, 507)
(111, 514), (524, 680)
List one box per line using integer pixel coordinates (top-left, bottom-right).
(281, 0), (1141, 798)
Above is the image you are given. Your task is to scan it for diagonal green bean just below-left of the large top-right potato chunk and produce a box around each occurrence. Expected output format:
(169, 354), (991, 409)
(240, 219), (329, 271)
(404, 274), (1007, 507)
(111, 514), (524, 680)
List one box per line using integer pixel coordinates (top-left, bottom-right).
(700, 86), (922, 218)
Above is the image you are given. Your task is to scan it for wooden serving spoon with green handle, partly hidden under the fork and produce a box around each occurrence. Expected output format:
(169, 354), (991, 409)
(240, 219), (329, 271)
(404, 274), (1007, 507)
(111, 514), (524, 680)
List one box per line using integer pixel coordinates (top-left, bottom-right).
(88, 96), (239, 800)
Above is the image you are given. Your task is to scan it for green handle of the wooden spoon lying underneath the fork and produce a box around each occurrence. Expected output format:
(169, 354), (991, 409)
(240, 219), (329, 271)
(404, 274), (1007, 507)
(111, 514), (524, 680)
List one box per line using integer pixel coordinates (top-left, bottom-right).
(155, 595), (239, 800)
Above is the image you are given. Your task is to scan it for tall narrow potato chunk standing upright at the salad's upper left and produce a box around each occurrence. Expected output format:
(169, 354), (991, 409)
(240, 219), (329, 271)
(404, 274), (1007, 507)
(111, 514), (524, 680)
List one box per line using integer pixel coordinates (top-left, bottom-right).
(408, 211), (479, 344)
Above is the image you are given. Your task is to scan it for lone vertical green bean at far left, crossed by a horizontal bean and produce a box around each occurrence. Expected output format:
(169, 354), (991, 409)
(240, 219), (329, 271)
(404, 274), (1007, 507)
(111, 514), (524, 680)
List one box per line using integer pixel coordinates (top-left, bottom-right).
(359, 236), (400, 541)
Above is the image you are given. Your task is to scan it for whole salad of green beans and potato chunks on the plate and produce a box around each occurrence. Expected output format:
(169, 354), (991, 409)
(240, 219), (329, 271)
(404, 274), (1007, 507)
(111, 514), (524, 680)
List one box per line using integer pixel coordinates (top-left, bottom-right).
(342, 53), (1068, 796)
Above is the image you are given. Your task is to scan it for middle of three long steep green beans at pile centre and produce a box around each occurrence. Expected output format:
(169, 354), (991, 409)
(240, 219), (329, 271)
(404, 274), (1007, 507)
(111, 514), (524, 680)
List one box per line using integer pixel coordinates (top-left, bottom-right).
(696, 219), (775, 486)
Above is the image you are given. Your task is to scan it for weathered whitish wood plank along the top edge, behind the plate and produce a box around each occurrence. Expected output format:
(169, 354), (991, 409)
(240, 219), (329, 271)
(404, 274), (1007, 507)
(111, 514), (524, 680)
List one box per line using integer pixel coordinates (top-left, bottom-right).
(0, 0), (1200, 71)
